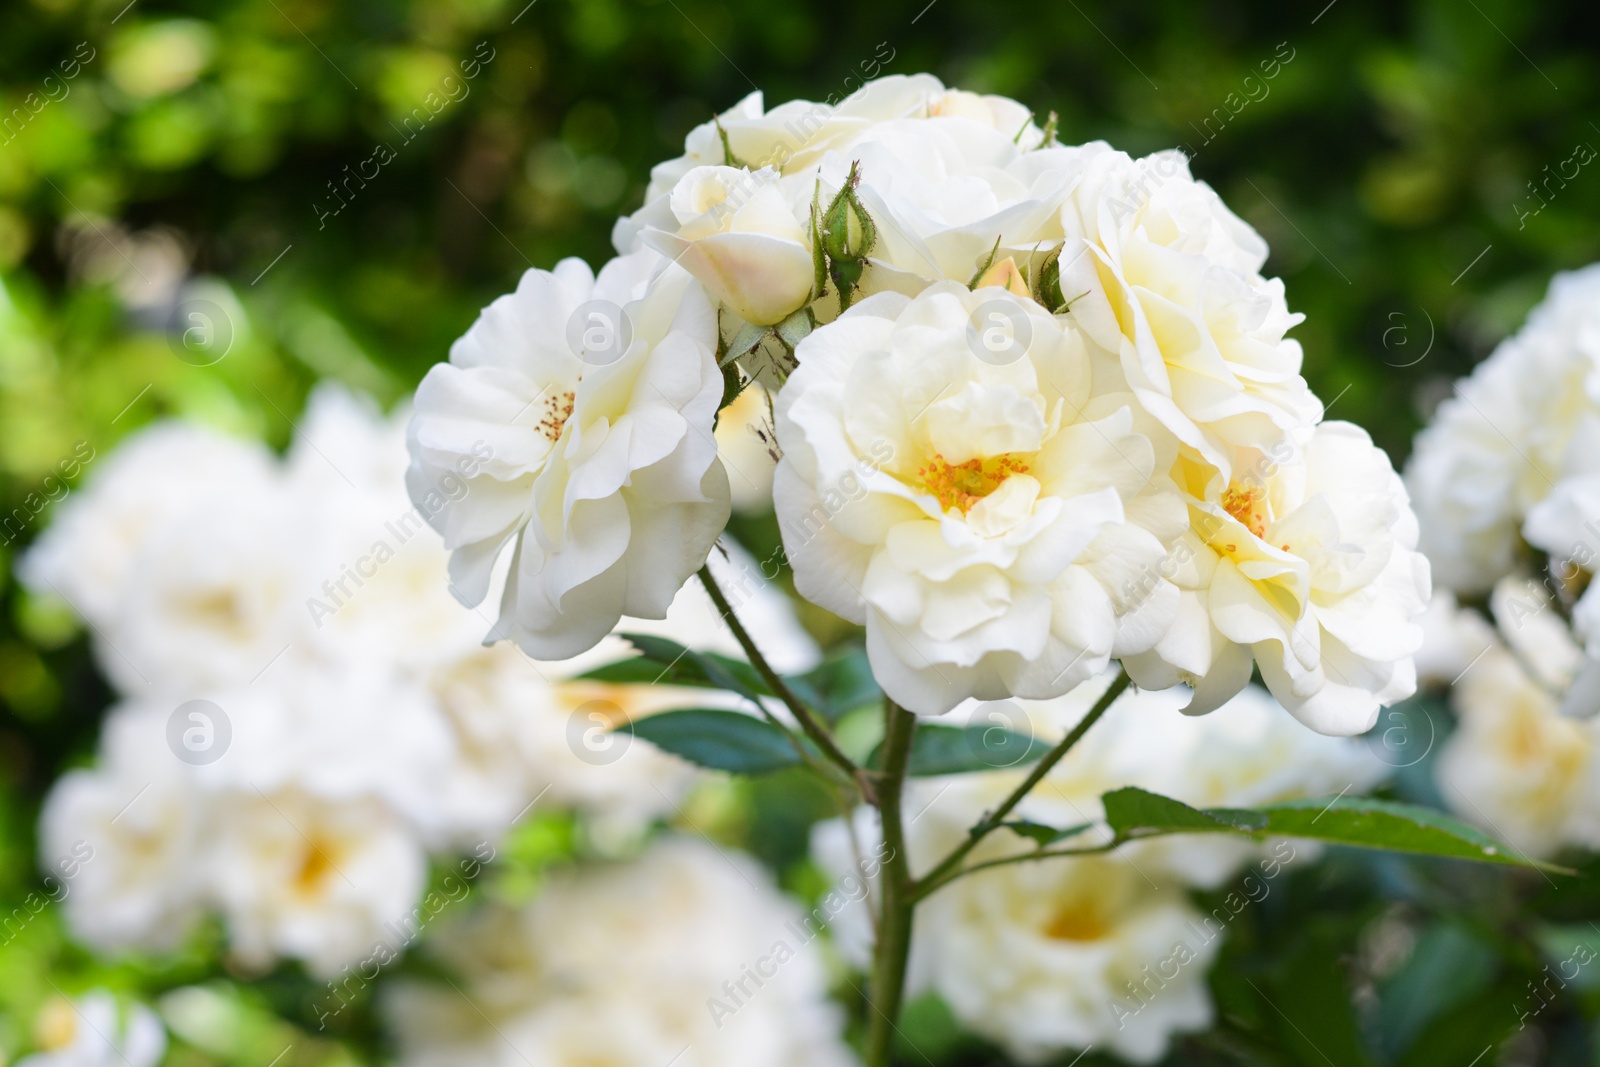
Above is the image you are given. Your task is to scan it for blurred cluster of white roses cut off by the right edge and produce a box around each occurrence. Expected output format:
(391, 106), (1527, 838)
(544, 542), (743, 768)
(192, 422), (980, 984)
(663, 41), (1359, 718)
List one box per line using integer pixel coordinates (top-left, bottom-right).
(1406, 266), (1600, 856)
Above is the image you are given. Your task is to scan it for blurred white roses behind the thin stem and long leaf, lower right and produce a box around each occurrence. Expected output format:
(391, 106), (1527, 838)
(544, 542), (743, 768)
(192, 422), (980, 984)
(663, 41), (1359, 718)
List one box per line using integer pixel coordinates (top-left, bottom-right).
(813, 680), (1387, 1064)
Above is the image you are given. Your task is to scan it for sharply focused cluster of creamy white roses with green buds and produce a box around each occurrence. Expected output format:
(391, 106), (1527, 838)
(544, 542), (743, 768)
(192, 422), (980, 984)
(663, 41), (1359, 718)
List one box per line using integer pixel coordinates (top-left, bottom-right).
(410, 68), (1429, 733)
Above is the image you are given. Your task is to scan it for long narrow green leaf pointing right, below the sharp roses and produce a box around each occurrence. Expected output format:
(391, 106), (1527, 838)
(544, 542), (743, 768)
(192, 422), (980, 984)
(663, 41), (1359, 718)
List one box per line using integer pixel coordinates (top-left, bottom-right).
(1102, 787), (1571, 873)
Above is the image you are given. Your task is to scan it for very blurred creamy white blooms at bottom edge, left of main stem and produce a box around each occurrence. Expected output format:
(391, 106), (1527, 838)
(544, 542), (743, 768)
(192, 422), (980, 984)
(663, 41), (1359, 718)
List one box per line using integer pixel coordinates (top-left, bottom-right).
(387, 838), (851, 1067)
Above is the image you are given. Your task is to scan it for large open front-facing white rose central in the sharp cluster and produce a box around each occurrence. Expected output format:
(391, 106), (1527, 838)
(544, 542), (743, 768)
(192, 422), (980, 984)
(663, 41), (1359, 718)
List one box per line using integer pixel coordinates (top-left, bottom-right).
(776, 283), (1182, 715)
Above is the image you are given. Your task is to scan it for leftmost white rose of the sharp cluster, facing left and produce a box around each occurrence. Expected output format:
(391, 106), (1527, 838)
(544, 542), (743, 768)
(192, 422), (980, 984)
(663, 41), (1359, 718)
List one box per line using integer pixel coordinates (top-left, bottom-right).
(408, 251), (730, 659)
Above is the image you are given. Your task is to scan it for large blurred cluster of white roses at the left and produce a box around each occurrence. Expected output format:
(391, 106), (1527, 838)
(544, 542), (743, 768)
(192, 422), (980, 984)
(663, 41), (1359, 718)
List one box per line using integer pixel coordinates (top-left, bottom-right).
(21, 387), (816, 974)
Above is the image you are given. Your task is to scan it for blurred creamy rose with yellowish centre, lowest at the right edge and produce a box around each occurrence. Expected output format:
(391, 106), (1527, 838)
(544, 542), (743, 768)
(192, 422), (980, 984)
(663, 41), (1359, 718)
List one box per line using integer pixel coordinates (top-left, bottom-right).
(1435, 646), (1600, 856)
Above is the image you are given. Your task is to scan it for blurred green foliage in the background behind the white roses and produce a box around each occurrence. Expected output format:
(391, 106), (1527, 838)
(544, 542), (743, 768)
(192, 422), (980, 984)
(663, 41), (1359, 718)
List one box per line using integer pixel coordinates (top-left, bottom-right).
(0, 0), (1600, 1067)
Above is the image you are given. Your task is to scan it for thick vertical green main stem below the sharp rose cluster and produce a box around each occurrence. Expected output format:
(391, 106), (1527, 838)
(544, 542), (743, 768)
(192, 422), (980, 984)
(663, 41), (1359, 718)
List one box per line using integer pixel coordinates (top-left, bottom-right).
(866, 697), (917, 1067)
